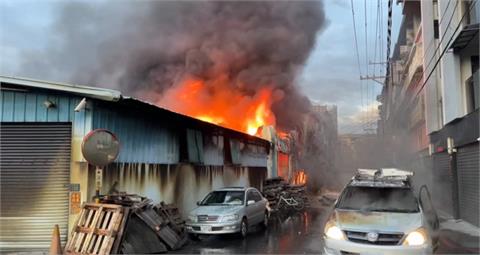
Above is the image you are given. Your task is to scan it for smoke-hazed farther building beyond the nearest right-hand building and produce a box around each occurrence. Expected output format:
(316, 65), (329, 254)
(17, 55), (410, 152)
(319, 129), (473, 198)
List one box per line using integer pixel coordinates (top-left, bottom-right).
(378, 1), (428, 164)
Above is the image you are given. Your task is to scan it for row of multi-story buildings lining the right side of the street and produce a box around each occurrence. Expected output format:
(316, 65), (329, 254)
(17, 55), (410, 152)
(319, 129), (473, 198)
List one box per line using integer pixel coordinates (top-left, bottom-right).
(378, 0), (480, 226)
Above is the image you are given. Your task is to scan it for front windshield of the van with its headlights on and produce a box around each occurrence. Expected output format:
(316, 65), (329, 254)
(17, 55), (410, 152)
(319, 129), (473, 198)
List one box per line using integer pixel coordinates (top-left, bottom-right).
(336, 186), (419, 212)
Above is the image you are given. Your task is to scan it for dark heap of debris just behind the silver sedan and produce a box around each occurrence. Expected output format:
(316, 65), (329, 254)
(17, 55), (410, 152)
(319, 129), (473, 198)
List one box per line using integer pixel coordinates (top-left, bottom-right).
(262, 177), (309, 212)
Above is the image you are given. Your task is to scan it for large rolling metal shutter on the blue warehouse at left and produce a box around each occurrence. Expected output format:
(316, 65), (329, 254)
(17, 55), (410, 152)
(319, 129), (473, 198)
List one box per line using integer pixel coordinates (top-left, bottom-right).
(0, 122), (71, 251)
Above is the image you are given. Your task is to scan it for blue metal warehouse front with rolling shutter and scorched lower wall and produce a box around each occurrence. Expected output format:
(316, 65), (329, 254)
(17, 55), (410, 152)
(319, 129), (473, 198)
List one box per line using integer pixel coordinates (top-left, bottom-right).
(0, 77), (271, 252)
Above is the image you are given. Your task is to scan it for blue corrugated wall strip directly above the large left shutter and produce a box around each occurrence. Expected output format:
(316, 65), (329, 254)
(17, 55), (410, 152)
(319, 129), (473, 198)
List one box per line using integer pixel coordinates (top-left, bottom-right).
(0, 90), (90, 134)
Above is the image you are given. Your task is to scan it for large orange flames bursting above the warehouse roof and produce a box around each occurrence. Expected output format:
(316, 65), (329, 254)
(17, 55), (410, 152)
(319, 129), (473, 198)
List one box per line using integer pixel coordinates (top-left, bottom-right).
(158, 79), (275, 135)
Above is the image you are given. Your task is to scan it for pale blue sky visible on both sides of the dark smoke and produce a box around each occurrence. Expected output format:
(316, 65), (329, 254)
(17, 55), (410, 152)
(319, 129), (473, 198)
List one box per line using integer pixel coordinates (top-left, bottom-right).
(0, 0), (401, 133)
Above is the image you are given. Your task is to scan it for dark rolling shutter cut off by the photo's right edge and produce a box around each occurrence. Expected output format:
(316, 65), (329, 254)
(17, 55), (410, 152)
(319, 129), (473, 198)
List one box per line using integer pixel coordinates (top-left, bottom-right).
(457, 143), (480, 226)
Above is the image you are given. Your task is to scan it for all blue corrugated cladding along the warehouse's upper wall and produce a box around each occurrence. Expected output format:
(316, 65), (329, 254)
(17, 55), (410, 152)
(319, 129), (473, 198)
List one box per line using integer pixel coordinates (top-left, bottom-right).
(0, 90), (266, 166)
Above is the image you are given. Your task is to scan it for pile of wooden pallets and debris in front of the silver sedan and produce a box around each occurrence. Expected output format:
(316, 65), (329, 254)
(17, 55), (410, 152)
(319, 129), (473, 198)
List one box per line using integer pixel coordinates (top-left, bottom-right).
(65, 194), (188, 254)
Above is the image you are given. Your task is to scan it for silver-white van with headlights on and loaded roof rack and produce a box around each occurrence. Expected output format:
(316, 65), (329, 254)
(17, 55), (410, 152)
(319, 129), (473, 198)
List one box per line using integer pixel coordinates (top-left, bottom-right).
(324, 168), (439, 254)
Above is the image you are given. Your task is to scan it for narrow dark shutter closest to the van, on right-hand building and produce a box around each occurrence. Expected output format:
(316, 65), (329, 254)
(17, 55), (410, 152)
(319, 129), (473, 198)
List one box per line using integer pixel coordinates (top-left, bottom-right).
(432, 152), (453, 215)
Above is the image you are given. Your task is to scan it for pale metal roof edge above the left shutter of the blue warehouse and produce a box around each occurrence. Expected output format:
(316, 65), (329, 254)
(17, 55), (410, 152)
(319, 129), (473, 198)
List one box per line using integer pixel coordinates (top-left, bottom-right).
(0, 75), (122, 101)
